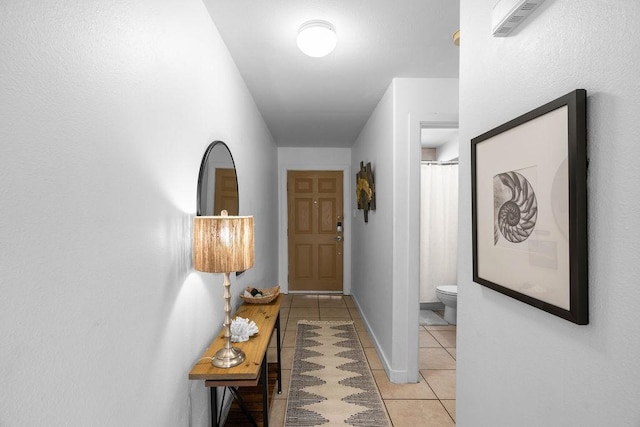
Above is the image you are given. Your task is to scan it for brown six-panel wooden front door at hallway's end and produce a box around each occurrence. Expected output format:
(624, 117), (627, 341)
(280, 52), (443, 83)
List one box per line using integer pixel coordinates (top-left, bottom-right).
(287, 171), (344, 292)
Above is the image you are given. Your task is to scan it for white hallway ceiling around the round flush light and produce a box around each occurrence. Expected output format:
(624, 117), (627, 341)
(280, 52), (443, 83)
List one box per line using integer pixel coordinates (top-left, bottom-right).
(204, 0), (460, 147)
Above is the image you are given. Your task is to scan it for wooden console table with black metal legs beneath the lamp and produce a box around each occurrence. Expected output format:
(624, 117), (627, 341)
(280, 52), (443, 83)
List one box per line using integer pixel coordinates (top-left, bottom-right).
(189, 295), (283, 427)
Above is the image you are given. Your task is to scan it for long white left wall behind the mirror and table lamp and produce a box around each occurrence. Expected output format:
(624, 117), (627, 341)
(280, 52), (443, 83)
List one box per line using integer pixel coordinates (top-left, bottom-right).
(0, 0), (277, 427)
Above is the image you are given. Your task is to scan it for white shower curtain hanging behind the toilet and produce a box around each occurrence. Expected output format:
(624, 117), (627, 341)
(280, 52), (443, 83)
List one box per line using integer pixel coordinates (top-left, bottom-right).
(420, 163), (458, 303)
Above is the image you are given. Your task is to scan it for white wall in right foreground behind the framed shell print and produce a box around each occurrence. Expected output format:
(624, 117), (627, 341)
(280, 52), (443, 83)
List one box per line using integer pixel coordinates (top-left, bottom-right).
(456, 0), (640, 427)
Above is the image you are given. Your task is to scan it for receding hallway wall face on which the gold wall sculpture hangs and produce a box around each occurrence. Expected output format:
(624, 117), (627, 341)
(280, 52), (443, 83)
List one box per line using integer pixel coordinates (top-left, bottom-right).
(350, 85), (394, 372)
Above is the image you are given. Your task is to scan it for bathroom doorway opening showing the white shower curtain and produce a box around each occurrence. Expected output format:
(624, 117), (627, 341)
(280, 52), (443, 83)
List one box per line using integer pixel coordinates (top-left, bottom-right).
(419, 122), (459, 325)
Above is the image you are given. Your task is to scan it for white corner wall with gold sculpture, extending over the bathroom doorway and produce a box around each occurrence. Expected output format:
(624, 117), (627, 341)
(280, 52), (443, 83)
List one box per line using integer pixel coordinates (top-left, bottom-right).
(351, 78), (458, 383)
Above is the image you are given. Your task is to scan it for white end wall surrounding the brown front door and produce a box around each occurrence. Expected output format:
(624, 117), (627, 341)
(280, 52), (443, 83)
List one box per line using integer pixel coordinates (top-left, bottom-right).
(278, 147), (355, 295)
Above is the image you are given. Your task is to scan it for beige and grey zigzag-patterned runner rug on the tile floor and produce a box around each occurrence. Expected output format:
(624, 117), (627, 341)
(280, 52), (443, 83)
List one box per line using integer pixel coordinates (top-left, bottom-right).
(285, 320), (391, 427)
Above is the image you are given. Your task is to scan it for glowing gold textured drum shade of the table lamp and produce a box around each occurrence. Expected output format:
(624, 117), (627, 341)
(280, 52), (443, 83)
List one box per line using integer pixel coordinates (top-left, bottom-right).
(193, 215), (255, 273)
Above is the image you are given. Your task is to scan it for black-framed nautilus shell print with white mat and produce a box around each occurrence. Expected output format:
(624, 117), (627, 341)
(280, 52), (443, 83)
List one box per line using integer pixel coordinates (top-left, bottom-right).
(471, 89), (589, 325)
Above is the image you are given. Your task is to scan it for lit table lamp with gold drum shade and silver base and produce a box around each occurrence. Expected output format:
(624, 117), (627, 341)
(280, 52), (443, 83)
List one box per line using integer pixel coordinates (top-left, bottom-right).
(193, 211), (255, 368)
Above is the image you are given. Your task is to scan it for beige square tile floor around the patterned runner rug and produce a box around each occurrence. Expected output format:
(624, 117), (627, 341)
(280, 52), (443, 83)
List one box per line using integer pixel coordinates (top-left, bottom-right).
(268, 294), (456, 427)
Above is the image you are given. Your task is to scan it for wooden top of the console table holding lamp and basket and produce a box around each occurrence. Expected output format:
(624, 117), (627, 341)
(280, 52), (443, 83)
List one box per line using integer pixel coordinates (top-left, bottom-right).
(189, 294), (283, 381)
